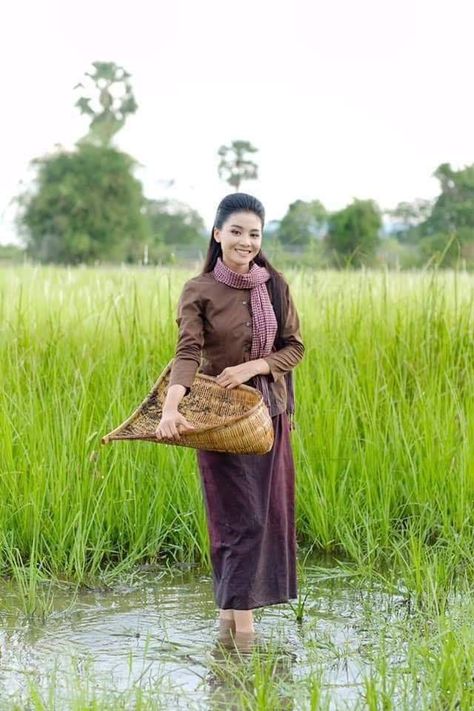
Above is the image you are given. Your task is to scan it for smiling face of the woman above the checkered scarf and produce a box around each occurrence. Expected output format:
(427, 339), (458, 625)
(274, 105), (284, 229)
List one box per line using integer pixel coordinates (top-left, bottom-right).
(214, 212), (262, 274)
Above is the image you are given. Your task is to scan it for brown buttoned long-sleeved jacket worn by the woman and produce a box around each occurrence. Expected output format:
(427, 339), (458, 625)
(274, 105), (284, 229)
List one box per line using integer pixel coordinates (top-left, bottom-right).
(170, 272), (304, 417)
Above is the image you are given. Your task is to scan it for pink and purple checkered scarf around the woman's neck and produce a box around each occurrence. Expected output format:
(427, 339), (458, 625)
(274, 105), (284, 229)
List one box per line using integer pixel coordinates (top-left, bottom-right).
(213, 257), (278, 408)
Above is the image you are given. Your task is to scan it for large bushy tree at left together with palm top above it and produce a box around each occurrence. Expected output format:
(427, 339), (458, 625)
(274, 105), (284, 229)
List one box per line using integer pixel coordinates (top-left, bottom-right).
(17, 62), (149, 264)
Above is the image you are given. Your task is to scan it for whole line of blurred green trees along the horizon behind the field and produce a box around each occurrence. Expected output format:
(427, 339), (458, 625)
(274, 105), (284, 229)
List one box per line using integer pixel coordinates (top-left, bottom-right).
(4, 62), (474, 268)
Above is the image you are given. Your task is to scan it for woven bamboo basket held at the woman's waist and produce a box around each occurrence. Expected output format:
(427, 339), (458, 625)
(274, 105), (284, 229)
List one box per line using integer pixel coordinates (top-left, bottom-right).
(101, 361), (273, 454)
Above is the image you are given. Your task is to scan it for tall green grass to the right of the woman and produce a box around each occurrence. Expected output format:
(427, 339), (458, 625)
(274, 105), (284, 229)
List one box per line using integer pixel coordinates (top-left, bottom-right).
(294, 273), (474, 597)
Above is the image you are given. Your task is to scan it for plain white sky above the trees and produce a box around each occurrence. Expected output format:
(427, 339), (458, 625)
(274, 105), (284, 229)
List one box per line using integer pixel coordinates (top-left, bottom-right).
(0, 0), (474, 242)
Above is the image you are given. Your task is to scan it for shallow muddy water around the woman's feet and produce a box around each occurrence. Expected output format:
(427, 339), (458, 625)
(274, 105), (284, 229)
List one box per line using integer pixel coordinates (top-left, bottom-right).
(0, 565), (408, 710)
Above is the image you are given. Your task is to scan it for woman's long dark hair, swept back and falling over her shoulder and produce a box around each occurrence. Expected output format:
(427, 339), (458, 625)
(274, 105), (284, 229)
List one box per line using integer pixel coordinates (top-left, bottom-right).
(202, 193), (287, 342)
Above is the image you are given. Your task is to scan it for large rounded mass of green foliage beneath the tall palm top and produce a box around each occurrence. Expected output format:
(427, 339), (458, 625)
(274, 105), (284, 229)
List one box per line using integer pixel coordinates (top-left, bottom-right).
(19, 144), (148, 264)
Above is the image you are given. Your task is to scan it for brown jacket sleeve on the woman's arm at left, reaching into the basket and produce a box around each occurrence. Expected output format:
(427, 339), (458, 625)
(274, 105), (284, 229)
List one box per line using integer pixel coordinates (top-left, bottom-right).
(169, 281), (204, 395)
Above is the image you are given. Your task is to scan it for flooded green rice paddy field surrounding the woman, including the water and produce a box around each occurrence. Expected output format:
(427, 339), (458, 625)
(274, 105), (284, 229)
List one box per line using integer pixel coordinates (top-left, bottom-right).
(0, 265), (474, 711)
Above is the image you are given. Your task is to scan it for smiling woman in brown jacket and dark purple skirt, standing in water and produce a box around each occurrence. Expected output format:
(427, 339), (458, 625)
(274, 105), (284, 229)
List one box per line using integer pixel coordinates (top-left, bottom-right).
(156, 193), (304, 639)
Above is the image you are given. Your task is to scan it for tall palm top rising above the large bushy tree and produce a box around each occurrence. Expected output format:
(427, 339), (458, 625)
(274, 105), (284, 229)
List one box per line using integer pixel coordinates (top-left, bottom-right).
(74, 62), (138, 146)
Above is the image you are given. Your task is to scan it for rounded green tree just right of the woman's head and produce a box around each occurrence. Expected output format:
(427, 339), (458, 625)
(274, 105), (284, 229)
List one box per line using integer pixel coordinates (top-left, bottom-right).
(277, 200), (328, 246)
